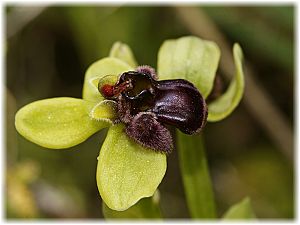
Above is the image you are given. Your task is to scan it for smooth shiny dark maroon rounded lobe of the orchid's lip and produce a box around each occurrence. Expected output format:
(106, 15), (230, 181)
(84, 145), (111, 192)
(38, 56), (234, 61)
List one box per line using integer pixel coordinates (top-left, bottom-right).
(151, 79), (207, 134)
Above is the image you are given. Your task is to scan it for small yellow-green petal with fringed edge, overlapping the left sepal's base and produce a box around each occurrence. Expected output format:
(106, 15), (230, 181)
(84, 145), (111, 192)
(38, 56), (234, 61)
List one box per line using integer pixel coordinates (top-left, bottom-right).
(90, 100), (118, 124)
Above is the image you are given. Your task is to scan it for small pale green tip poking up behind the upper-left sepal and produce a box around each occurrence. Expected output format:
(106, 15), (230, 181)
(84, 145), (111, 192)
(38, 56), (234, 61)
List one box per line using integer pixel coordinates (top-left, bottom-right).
(109, 42), (138, 68)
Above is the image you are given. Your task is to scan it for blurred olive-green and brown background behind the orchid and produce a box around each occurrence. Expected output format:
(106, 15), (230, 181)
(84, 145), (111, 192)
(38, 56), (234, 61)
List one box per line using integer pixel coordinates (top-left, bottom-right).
(4, 4), (295, 219)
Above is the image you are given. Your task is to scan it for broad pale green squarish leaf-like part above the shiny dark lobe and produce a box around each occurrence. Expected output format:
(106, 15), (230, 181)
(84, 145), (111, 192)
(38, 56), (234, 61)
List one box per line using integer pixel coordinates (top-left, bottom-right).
(158, 36), (220, 98)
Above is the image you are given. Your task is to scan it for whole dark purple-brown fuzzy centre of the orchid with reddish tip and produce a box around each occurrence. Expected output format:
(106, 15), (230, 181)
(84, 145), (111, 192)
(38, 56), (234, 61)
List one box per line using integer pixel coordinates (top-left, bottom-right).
(98, 66), (207, 153)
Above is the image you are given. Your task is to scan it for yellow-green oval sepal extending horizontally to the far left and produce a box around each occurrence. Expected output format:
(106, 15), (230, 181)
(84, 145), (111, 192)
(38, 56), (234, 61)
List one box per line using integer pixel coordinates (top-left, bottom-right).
(15, 97), (109, 149)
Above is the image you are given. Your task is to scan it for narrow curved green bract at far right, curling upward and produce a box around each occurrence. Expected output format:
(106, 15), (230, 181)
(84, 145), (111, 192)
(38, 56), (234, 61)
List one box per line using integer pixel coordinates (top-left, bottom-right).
(207, 44), (245, 122)
